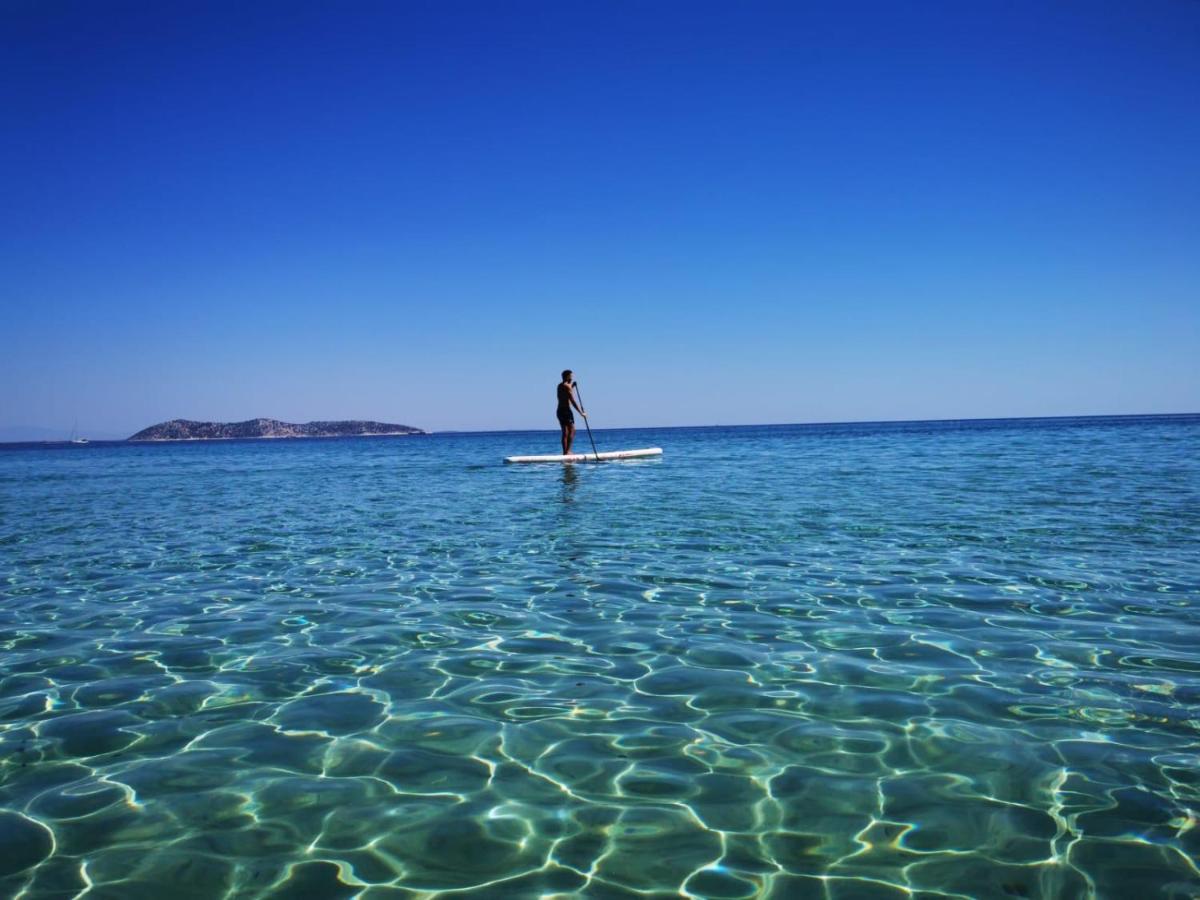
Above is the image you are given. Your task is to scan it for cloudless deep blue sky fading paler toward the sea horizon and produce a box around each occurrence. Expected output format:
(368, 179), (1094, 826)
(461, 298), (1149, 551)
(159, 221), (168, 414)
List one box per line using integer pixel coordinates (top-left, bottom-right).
(0, 0), (1200, 436)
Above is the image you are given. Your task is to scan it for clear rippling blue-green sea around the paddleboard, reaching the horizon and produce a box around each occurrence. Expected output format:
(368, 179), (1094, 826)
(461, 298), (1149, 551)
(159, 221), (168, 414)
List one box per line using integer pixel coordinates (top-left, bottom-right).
(0, 416), (1200, 899)
